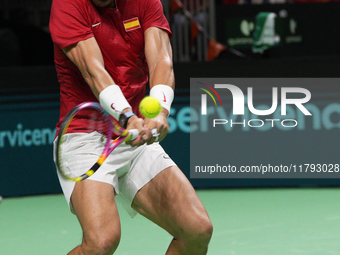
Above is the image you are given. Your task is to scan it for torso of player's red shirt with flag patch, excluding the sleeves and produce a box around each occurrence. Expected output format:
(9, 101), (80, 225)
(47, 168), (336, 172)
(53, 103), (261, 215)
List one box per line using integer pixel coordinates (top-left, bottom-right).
(55, 0), (148, 130)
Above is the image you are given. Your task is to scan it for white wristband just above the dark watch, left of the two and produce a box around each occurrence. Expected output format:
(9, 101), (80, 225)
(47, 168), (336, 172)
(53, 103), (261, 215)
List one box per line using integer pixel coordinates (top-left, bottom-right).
(99, 85), (132, 120)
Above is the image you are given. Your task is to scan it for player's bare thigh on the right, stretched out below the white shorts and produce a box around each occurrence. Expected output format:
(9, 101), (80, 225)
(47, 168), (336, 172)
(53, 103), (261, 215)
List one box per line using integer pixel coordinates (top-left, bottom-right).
(132, 166), (212, 238)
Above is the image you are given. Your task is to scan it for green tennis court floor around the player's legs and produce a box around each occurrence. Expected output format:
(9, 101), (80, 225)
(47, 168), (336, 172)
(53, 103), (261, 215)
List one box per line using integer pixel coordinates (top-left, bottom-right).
(0, 189), (340, 255)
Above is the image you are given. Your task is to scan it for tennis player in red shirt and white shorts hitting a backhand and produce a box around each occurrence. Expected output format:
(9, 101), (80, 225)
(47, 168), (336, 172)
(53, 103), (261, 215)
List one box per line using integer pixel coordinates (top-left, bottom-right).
(50, 0), (212, 255)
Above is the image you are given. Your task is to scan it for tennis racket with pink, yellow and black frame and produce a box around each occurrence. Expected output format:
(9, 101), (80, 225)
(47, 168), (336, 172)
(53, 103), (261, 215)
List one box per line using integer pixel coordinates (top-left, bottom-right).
(54, 102), (138, 182)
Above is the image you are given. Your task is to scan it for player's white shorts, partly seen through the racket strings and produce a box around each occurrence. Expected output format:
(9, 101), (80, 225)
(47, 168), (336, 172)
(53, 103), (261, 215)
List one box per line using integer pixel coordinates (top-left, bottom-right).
(54, 132), (176, 217)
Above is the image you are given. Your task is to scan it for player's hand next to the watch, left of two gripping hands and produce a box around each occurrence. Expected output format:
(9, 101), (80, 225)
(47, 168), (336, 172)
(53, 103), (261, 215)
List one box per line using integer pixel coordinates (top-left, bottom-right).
(126, 116), (152, 147)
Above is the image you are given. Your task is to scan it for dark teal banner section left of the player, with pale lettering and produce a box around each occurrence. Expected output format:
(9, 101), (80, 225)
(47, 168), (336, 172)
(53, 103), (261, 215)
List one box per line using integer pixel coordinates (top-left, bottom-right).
(0, 100), (61, 196)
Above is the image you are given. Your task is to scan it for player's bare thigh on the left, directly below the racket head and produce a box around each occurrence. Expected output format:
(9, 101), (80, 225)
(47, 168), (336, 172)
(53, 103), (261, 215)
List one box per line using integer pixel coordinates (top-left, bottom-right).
(71, 180), (121, 245)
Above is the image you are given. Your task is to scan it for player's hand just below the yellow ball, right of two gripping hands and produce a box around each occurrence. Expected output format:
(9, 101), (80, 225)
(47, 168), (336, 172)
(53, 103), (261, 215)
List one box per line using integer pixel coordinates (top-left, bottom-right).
(144, 109), (169, 144)
